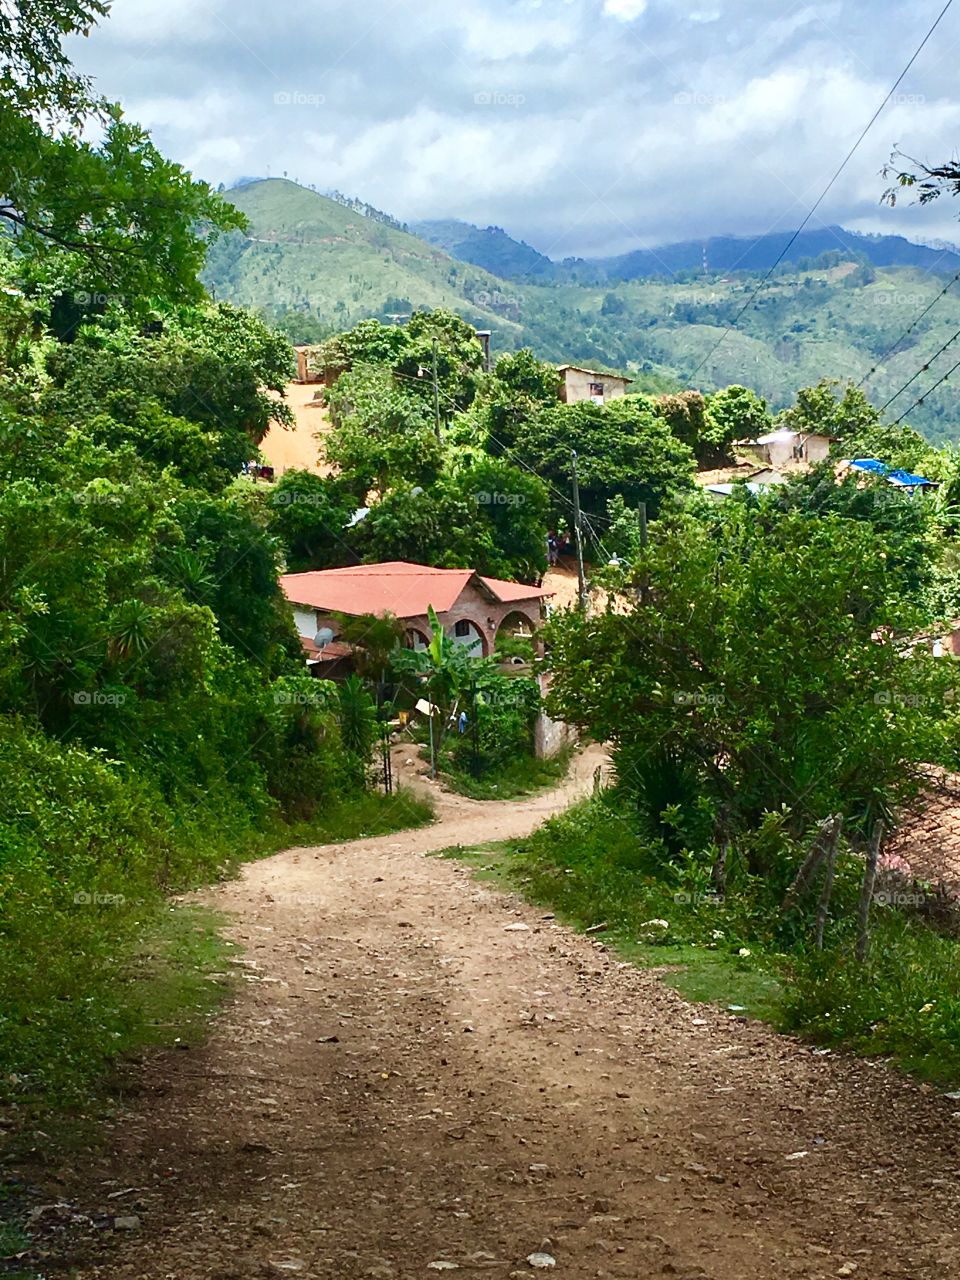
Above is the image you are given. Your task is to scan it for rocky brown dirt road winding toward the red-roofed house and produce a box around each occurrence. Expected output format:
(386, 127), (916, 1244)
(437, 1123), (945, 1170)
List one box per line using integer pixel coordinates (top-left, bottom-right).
(41, 754), (960, 1280)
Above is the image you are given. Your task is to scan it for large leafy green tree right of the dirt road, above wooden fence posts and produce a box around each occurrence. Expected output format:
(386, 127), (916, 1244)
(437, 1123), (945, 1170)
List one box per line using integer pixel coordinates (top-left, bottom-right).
(548, 504), (951, 855)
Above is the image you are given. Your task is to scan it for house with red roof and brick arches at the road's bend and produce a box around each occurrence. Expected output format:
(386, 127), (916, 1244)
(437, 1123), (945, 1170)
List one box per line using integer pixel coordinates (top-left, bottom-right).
(280, 561), (552, 664)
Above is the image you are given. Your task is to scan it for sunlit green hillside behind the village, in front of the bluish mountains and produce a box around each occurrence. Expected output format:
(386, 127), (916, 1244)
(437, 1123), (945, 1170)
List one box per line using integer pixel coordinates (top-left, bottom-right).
(206, 179), (960, 443)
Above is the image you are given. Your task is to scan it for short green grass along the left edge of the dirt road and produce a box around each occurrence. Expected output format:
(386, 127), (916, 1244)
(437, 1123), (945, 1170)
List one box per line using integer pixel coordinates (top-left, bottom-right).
(0, 791), (433, 1126)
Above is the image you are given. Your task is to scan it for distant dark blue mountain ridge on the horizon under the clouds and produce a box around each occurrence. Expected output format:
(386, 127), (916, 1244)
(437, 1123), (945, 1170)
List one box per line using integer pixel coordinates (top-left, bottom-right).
(411, 221), (960, 284)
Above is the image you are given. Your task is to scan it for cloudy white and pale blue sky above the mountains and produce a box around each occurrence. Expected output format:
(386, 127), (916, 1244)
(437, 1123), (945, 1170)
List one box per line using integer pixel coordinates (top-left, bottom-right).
(72, 0), (960, 257)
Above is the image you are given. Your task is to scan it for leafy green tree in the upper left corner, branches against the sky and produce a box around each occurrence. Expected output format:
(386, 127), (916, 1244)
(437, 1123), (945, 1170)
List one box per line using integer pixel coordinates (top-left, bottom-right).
(0, 0), (244, 312)
